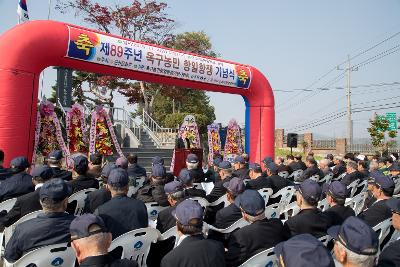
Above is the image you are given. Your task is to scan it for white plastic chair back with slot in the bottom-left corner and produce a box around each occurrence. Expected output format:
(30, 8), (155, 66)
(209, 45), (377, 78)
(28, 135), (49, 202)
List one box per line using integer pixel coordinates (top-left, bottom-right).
(4, 243), (76, 267)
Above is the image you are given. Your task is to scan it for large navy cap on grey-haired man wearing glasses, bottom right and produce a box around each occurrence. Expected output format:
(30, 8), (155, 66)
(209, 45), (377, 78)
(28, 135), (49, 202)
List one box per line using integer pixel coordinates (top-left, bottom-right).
(328, 216), (379, 255)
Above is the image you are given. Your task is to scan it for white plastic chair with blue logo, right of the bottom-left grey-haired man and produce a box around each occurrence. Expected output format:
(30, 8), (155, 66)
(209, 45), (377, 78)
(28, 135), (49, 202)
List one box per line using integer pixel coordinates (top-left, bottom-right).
(108, 228), (161, 267)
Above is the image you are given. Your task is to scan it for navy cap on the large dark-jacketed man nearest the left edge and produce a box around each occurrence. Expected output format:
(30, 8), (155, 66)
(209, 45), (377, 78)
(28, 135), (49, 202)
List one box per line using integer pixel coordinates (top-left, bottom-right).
(39, 178), (72, 201)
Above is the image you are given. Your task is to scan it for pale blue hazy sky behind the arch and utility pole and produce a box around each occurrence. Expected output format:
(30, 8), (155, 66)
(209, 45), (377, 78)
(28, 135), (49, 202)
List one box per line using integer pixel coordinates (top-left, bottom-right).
(0, 0), (400, 138)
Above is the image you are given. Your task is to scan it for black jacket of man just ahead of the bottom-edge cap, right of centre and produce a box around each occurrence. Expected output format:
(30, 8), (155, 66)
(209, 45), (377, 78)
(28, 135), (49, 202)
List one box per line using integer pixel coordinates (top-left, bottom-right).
(284, 209), (330, 238)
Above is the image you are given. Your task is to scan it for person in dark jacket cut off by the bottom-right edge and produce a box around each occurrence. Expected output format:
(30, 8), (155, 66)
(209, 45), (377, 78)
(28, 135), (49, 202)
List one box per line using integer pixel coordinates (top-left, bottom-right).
(377, 198), (400, 267)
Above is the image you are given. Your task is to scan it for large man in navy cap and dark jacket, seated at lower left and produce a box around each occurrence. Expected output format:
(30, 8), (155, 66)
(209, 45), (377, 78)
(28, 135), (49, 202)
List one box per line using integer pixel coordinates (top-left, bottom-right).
(4, 178), (75, 262)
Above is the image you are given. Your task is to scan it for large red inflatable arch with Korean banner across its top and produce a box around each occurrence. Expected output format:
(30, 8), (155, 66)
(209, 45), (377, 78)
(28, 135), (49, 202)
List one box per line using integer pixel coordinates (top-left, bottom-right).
(0, 21), (275, 165)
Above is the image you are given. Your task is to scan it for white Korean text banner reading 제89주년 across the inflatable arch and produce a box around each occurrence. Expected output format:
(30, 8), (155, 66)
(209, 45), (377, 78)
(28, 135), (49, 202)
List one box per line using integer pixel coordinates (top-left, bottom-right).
(66, 26), (251, 89)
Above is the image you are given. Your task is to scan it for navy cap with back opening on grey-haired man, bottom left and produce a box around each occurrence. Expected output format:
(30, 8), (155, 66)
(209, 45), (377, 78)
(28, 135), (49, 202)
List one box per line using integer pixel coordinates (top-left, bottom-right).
(69, 213), (108, 240)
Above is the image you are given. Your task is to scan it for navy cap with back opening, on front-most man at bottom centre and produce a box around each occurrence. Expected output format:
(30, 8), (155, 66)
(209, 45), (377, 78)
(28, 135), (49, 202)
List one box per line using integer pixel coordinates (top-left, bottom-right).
(171, 199), (203, 226)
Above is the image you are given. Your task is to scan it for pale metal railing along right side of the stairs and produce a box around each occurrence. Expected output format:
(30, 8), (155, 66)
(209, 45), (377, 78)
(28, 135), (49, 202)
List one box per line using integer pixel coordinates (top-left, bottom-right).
(142, 110), (175, 147)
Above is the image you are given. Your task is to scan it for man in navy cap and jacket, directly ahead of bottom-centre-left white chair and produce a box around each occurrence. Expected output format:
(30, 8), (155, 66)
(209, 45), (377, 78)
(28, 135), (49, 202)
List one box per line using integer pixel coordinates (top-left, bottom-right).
(95, 168), (148, 239)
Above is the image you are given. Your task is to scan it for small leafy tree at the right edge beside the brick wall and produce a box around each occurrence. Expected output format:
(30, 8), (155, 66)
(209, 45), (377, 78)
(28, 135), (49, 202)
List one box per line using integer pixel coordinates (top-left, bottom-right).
(367, 115), (397, 155)
